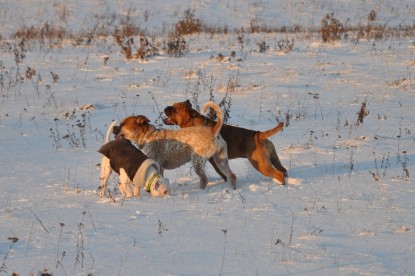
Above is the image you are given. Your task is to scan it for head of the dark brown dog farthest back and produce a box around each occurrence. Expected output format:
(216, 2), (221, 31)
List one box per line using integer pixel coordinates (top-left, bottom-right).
(163, 100), (201, 127)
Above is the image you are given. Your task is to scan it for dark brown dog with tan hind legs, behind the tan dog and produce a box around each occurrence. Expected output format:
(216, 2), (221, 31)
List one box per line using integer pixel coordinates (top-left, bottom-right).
(164, 100), (287, 184)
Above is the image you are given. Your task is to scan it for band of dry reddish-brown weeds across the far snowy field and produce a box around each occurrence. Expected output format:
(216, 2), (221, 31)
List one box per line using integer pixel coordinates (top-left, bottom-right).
(1, 10), (415, 50)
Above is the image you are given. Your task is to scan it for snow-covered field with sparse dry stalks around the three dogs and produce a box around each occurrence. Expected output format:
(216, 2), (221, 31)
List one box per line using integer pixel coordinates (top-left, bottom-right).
(0, 0), (415, 275)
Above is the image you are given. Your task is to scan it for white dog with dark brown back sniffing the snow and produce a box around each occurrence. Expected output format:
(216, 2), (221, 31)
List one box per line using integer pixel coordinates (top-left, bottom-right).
(98, 121), (169, 197)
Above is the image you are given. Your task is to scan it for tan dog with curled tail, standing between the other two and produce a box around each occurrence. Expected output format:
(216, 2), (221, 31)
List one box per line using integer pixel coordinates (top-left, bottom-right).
(113, 102), (236, 189)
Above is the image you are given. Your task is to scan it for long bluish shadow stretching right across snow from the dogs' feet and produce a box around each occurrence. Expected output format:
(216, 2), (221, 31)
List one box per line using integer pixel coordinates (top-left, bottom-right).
(96, 152), (415, 197)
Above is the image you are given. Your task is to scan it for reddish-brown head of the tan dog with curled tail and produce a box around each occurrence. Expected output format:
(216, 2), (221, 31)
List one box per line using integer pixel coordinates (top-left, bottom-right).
(112, 115), (154, 142)
